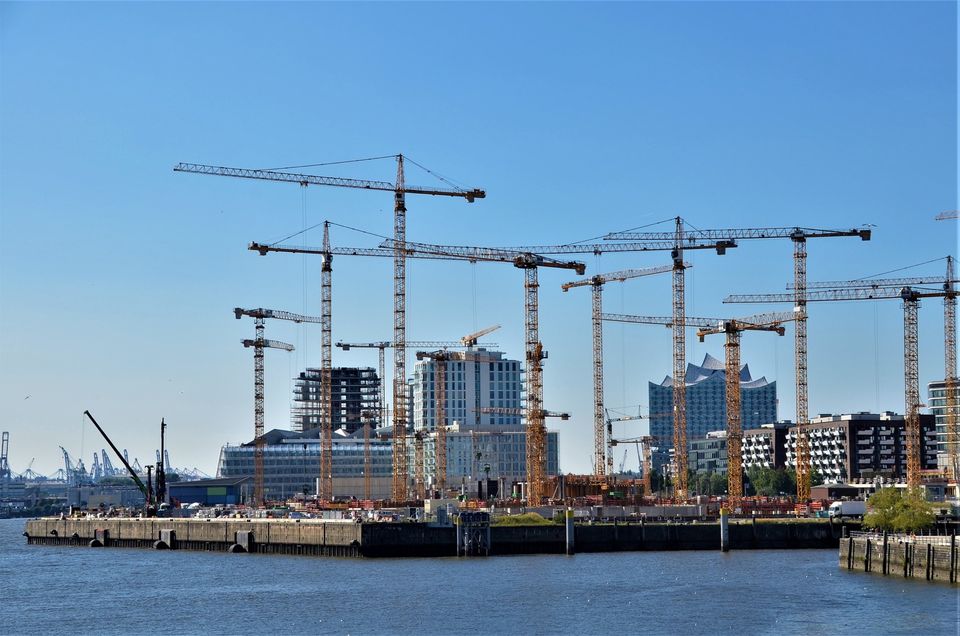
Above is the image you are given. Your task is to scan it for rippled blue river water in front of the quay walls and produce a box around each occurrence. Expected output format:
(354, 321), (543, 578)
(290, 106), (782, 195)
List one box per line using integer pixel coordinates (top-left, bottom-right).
(0, 519), (960, 635)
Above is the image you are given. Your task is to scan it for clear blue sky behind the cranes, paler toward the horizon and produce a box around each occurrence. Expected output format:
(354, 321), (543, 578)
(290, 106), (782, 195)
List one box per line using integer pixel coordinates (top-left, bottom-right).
(0, 2), (958, 474)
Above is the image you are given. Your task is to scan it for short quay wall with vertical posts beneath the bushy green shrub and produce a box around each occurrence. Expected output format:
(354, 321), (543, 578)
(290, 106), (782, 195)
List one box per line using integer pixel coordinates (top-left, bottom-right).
(840, 534), (960, 585)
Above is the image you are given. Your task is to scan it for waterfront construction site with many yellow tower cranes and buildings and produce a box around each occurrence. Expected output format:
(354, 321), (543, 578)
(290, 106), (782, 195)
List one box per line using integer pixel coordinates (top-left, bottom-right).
(9, 155), (960, 540)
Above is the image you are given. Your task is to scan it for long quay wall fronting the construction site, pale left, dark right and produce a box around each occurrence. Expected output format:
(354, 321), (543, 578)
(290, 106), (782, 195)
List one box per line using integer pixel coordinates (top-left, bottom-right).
(24, 518), (856, 557)
